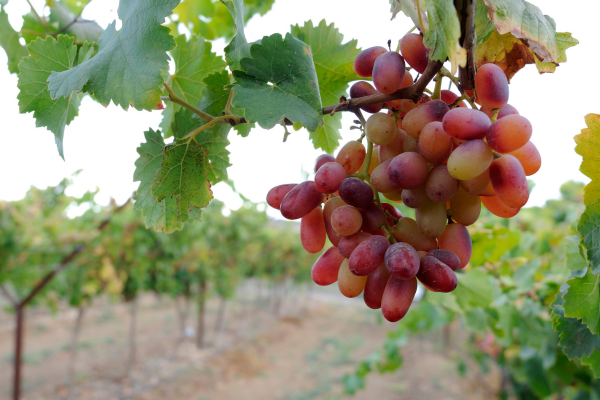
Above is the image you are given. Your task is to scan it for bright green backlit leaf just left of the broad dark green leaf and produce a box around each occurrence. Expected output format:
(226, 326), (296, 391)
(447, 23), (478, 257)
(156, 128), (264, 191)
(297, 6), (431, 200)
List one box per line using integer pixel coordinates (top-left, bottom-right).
(160, 35), (225, 137)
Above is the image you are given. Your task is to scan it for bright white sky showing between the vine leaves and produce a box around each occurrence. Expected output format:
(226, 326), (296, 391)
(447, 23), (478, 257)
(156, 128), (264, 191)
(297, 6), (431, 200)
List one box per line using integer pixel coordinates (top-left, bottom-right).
(0, 0), (600, 216)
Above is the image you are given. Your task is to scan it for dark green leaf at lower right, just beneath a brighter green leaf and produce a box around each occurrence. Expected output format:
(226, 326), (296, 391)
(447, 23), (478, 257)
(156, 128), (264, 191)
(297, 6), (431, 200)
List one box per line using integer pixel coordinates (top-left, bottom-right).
(552, 295), (600, 360)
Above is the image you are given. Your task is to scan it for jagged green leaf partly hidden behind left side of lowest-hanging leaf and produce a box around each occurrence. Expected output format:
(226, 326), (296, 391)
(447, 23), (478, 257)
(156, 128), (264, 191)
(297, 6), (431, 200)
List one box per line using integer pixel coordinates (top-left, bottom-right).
(133, 129), (202, 233)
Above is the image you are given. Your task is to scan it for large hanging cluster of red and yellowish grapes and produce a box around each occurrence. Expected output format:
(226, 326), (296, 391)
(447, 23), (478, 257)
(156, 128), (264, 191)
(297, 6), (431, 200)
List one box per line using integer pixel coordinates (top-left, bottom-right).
(267, 34), (541, 322)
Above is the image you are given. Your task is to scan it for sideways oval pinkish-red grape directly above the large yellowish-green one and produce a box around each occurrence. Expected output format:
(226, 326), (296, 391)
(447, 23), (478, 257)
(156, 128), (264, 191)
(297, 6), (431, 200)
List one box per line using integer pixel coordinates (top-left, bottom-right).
(442, 108), (492, 140)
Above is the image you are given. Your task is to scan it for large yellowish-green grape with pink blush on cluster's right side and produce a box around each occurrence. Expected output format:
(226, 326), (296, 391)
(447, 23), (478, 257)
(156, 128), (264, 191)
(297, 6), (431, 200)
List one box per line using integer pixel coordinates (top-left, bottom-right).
(448, 139), (494, 181)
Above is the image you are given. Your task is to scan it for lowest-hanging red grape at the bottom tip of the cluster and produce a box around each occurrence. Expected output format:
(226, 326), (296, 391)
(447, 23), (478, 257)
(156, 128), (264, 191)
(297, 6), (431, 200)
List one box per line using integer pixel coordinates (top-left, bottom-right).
(381, 276), (417, 322)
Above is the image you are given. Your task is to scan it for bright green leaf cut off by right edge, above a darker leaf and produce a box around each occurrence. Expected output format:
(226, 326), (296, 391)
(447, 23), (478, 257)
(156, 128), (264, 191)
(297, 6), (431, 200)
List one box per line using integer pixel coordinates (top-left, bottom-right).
(563, 271), (600, 334)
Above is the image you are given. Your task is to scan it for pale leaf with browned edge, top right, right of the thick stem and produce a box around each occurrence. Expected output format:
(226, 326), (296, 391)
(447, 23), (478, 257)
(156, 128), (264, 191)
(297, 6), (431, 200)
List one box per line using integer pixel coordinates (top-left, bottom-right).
(484, 0), (560, 64)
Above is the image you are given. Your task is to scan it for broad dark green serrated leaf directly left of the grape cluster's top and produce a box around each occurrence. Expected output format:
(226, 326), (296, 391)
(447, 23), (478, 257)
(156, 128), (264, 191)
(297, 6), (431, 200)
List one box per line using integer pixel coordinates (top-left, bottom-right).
(233, 33), (323, 131)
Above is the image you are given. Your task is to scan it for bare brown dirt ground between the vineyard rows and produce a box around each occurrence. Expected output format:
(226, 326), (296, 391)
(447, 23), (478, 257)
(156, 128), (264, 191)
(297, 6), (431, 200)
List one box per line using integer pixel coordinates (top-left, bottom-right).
(0, 284), (499, 400)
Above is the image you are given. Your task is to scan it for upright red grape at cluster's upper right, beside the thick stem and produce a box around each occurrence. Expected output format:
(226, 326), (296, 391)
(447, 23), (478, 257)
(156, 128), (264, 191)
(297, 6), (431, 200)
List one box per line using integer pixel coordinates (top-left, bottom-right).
(475, 64), (508, 109)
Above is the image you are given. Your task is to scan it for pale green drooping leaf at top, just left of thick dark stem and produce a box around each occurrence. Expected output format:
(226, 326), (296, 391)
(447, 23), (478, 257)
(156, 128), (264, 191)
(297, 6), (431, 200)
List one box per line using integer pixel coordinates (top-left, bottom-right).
(423, 0), (467, 74)
